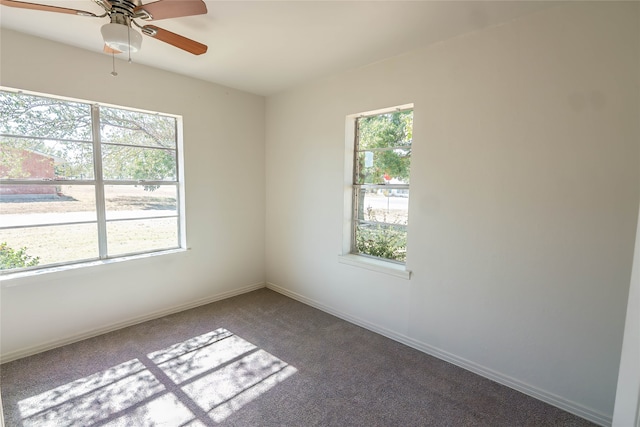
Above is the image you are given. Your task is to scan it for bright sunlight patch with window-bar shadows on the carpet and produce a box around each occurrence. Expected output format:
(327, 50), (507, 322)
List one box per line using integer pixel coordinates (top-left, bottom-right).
(18, 328), (297, 427)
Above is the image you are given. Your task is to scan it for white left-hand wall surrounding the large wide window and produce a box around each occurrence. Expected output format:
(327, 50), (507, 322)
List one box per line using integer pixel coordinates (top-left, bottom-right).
(0, 30), (265, 360)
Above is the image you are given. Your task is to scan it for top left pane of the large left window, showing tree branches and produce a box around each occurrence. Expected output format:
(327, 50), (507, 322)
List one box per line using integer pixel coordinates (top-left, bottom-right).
(0, 91), (91, 141)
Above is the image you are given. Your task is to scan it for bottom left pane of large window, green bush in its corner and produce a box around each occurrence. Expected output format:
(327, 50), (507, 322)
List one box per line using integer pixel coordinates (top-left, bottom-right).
(0, 223), (98, 270)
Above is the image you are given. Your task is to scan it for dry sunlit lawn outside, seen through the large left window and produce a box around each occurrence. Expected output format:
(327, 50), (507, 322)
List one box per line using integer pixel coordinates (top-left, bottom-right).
(0, 185), (178, 266)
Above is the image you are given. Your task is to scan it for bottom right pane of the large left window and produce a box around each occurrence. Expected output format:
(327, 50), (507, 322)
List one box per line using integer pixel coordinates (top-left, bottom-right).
(107, 218), (179, 256)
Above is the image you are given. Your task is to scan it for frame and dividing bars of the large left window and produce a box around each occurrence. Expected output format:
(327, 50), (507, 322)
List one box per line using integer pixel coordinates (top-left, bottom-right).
(0, 86), (187, 277)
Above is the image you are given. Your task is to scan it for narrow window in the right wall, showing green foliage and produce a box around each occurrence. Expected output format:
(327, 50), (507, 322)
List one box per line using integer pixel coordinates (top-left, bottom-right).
(351, 109), (413, 263)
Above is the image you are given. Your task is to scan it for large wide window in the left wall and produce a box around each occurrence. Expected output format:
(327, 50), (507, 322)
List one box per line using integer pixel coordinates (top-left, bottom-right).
(0, 90), (184, 273)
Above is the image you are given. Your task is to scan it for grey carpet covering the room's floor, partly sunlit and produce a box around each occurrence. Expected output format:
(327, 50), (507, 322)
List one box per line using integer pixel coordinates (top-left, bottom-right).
(1, 289), (592, 427)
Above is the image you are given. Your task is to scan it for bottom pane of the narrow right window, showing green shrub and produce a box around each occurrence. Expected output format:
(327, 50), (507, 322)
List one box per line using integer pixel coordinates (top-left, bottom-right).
(356, 224), (407, 262)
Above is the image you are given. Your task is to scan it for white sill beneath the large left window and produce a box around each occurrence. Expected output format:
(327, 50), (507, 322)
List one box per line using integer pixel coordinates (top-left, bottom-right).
(0, 248), (189, 288)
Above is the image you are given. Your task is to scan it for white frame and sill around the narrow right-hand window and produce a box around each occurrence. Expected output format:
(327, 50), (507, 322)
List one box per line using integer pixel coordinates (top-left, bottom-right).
(338, 104), (415, 280)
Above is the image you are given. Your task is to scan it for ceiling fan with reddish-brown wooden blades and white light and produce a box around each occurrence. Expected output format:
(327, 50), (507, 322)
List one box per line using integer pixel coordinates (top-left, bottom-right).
(0, 0), (207, 55)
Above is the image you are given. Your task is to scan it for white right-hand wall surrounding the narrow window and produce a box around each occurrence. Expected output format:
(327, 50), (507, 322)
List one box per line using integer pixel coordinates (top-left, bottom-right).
(266, 2), (640, 424)
